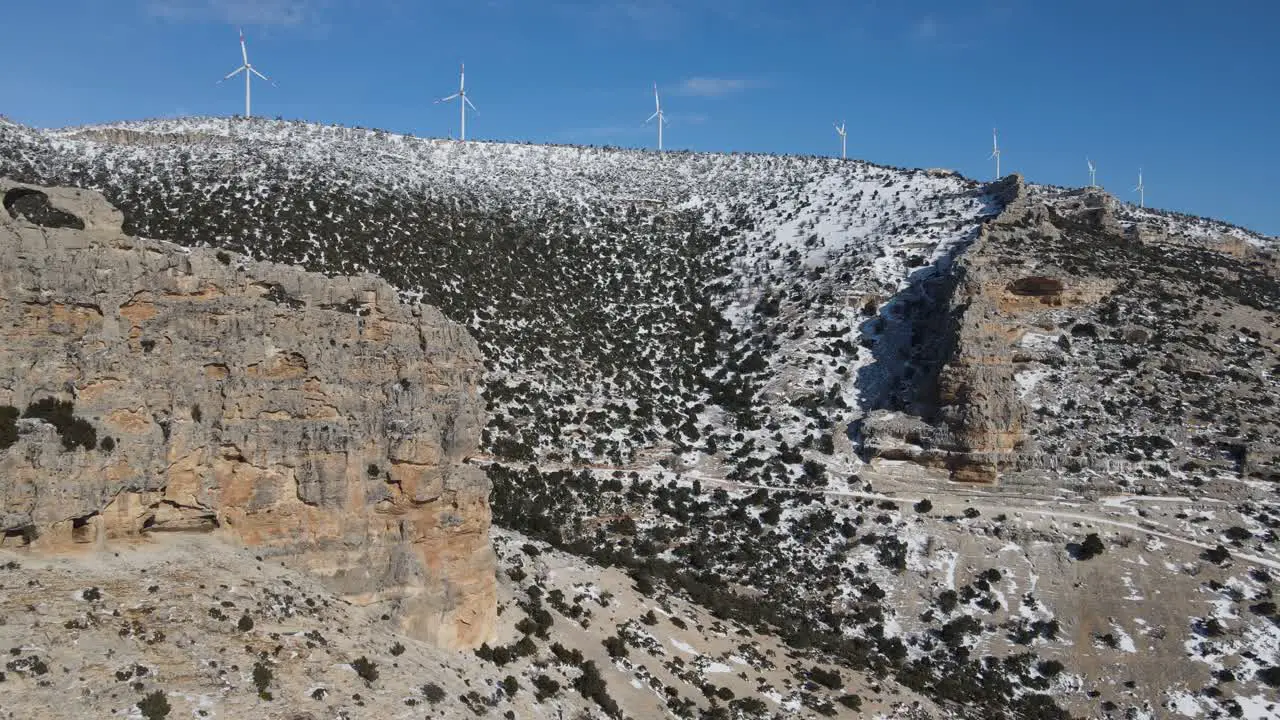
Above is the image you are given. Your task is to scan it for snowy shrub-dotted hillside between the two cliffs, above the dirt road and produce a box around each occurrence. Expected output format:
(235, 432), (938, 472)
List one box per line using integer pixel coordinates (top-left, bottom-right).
(0, 118), (998, 480)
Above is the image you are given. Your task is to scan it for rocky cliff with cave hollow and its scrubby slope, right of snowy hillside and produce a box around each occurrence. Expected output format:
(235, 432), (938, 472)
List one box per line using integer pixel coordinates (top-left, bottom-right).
(864, 176), (1280, 486)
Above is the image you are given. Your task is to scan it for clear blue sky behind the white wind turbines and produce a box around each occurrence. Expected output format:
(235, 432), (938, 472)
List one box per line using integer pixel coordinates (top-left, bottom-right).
(0, 0), (1280, 234)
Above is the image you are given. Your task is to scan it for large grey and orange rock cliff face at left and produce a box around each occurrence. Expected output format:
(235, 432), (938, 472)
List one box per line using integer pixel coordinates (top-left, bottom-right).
(0, 181), (495, 647)
